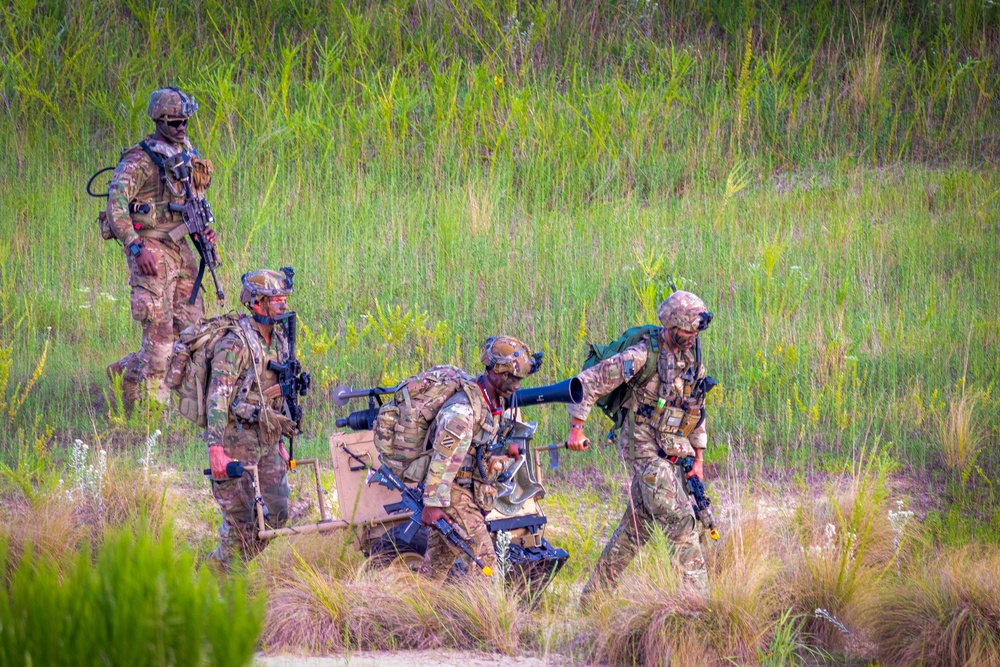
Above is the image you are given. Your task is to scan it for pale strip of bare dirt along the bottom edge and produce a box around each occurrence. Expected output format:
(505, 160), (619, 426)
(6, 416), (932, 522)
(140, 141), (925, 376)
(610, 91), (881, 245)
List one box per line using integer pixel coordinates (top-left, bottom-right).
(254, 650), (561, 667)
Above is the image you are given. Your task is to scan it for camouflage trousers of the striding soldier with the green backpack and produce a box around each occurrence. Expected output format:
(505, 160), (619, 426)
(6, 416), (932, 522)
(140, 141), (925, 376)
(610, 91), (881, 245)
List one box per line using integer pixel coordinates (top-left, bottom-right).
(581, 458), (708, 604)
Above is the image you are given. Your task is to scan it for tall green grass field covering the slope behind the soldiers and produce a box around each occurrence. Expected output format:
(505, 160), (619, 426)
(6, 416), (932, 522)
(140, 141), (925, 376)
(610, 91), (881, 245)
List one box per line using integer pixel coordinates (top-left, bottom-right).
(0, 0), (1000, 664)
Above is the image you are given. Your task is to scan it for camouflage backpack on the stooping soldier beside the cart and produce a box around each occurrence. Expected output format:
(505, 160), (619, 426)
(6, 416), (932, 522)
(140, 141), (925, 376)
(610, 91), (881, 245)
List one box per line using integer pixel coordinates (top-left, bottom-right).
(372, 365), (479, 482)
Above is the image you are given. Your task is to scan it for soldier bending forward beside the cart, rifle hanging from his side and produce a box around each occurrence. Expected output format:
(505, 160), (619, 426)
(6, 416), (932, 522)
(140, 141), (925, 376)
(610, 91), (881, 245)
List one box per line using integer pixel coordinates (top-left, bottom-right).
(420, 336), (532, 579)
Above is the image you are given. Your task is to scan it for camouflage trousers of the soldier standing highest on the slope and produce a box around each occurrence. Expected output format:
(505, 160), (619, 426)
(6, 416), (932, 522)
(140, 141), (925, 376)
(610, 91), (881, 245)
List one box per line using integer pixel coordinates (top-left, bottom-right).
(108, 238), (205, 403)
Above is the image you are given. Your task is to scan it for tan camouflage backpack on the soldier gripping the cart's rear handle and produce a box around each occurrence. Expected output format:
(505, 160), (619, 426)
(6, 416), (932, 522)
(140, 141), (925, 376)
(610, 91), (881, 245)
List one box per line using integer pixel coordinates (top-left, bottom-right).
(166, 313), (262, 428)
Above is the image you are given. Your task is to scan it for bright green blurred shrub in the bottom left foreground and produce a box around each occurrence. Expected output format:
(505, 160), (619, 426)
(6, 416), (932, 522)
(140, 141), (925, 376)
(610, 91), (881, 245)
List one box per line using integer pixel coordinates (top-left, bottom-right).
(0, 531), (263, 667)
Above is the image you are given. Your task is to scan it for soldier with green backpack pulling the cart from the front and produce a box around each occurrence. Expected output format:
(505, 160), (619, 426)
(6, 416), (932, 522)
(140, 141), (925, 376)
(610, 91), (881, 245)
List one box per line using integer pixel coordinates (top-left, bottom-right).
(567, 291), (712, 605)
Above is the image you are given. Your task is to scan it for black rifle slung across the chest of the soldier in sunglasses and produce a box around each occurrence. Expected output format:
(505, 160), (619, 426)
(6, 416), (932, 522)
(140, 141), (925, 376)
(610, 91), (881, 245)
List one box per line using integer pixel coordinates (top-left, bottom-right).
(139, 141), (226, 307)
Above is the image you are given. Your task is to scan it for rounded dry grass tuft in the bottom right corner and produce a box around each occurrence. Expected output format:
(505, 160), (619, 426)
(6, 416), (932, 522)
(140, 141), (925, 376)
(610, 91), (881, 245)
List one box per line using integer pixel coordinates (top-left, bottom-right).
(870, 548), (1000, 667)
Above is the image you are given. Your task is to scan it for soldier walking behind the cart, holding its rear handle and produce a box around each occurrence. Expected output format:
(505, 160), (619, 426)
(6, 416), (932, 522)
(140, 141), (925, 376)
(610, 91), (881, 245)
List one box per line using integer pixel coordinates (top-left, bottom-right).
(205, 270), (296, 566)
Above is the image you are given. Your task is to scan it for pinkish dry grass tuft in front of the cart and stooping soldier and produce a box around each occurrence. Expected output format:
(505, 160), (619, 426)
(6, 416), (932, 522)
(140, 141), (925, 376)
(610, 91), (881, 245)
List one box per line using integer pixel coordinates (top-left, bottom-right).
(261, 536), (529, 655)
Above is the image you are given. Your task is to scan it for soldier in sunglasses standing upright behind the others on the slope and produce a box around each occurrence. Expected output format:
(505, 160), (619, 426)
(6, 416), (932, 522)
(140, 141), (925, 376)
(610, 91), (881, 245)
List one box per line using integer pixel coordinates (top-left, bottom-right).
(106, 88), (215, 407)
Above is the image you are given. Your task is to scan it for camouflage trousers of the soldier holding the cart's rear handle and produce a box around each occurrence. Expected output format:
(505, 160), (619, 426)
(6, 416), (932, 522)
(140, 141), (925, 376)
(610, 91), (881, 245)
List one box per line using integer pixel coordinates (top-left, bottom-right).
(211, 425), (289, 566)
